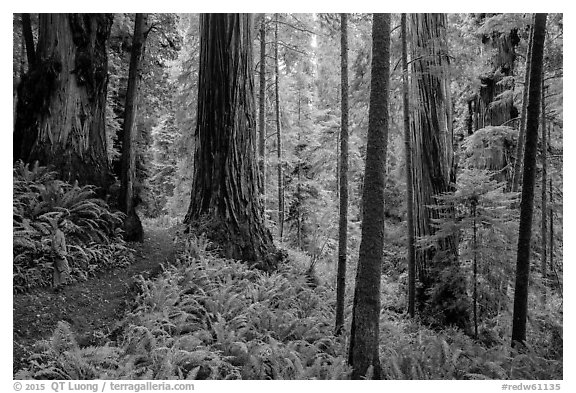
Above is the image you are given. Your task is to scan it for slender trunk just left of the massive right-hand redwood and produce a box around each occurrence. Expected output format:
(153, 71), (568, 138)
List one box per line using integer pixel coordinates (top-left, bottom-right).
(400, 14), (416, 317)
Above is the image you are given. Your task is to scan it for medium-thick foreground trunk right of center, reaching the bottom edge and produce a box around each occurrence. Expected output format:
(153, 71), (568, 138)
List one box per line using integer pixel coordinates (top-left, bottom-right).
(348, 14), (390, 379)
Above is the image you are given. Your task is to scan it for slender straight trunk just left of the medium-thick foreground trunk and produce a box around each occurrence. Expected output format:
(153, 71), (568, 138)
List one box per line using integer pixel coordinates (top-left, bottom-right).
(336, 14), (348, 334)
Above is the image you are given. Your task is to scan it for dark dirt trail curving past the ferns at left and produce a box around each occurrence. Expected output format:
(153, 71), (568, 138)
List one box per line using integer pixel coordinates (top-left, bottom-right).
(13, 227), (176, 372)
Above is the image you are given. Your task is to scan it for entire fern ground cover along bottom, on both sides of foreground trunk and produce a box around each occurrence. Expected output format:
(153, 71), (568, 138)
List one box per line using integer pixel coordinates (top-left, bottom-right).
(16, 236), (562, 379)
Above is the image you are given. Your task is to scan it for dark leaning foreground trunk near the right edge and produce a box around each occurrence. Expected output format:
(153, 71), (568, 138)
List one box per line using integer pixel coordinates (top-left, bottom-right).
(512, 14), (547, 346)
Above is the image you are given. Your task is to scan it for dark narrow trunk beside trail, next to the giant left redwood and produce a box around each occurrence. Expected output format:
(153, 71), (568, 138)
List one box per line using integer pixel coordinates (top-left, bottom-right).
(120, 14), (148, 242)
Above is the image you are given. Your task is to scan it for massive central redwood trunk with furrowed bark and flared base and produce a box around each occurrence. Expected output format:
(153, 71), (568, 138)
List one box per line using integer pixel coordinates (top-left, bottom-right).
(185, 14), (279, 270)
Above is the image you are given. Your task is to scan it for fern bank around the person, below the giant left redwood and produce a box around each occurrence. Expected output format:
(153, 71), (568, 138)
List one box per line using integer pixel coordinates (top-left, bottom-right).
(12, 161), (132, 292)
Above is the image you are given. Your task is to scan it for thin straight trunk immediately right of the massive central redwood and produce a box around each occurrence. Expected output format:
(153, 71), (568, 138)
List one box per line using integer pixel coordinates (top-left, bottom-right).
(258, 14), (266, 196)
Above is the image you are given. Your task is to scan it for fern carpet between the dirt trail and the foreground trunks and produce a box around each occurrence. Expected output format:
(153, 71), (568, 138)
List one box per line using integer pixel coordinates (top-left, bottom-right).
(18, 237), (349, 379)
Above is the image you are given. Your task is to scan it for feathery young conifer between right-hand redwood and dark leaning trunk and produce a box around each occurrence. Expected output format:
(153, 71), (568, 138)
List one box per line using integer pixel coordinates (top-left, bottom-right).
(418, 168), (518, 324)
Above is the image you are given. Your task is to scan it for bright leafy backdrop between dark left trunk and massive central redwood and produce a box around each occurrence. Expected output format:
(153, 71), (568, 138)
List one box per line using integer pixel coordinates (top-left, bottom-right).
(143, 14), (199, 218)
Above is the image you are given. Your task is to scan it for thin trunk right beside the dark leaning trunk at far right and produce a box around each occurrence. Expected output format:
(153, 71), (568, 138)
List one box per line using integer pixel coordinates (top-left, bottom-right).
(540, 74), (548, 305)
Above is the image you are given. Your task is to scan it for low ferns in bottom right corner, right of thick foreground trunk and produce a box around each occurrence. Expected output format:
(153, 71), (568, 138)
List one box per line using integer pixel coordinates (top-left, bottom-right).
(380, 322), (562, 380)
